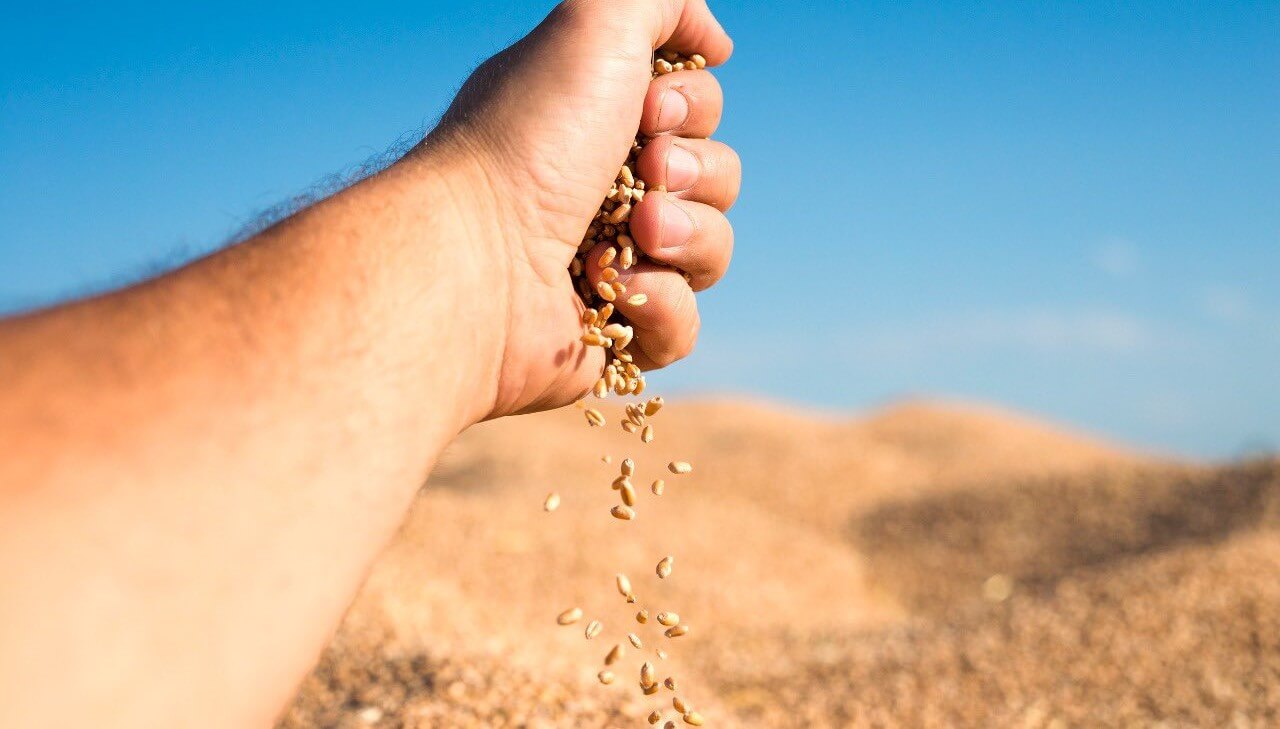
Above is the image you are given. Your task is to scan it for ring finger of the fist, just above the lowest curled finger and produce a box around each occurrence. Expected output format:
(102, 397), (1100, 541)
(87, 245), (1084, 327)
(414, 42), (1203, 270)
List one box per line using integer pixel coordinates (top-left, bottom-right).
(631, 192), (733, 292)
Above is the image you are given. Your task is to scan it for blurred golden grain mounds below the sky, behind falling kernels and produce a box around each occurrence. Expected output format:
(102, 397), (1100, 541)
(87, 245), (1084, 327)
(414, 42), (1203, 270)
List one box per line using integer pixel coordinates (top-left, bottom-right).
(280, 399), (1280, 729)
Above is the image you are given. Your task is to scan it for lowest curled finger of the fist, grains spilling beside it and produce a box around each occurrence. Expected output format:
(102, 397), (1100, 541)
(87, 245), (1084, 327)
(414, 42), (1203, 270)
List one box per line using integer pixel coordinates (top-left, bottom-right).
(588, 254), (701, 371)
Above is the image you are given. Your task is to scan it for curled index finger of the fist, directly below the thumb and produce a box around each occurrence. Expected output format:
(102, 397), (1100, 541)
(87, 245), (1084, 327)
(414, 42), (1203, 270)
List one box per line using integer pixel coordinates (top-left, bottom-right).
(640, 70), (724, 137)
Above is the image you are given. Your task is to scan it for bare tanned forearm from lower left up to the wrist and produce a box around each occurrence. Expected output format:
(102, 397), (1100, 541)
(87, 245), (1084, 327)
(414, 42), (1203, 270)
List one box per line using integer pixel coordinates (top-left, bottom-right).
(0, 144), (504, 726)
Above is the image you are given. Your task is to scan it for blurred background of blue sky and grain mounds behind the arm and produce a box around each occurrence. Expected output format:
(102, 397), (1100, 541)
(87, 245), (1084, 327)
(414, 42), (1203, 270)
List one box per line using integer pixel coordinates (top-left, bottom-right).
(0, 0), (1280, 729)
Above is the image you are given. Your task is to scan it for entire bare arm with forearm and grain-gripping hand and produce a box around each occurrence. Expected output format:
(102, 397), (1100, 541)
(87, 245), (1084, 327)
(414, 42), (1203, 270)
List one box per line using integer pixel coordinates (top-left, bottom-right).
(0, 0), (740, 728)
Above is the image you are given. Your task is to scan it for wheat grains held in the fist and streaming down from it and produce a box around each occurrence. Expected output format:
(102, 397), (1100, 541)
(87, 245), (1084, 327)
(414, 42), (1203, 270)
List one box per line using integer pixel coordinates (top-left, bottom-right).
(544, 50), (707, 729)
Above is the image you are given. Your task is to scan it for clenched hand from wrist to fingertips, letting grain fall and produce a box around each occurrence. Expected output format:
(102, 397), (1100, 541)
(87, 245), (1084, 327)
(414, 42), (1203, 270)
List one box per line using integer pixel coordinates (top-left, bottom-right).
(411, 0), (741, 417)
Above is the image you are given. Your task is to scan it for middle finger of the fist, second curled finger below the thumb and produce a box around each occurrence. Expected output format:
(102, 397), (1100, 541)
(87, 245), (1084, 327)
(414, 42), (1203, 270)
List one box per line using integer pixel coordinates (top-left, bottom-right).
(636, 137), (742, 212)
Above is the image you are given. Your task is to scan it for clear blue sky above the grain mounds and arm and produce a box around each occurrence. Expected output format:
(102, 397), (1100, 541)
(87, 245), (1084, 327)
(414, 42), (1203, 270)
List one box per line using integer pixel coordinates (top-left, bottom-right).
(0, 0), (1280, 457)
